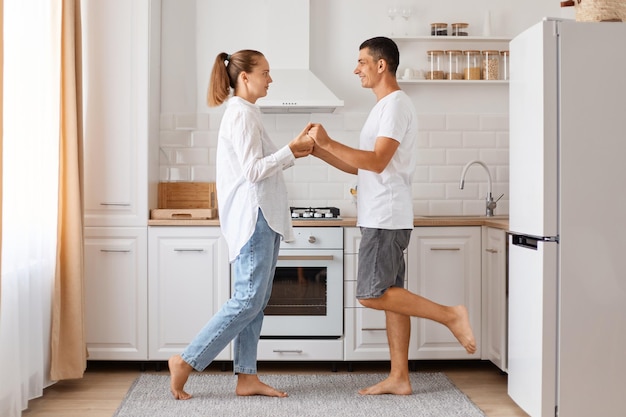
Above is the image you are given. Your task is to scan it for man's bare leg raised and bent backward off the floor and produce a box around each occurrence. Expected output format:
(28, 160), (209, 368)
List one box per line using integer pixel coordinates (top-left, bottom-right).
(360, 287), (476, 354)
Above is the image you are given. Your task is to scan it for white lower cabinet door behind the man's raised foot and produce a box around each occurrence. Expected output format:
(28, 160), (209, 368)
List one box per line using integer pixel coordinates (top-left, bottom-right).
(408, 227), (481, 359)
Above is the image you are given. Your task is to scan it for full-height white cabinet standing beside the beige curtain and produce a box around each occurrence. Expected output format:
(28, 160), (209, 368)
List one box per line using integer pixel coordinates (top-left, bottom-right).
(81, 0), (160, 360)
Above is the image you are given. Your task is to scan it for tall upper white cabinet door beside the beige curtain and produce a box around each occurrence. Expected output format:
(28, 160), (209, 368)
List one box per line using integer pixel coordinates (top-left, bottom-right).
(82, 0), (150, 226)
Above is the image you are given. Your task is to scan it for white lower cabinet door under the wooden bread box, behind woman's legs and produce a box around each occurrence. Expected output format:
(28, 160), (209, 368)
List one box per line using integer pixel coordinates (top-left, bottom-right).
(148, 226), (231, 360)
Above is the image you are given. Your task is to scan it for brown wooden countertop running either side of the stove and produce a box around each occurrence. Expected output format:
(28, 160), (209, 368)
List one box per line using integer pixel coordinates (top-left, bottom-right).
(148, 215), (509, 230)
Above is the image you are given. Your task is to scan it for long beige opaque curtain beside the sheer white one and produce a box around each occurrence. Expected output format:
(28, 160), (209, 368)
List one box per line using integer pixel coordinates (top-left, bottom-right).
(50, 0), (87, 380)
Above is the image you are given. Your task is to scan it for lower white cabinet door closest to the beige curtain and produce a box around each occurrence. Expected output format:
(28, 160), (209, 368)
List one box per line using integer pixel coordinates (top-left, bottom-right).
(84, 227), (148, 360)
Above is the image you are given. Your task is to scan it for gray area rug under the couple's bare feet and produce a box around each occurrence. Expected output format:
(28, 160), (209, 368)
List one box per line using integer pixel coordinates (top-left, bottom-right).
(113, 372), (485, 417)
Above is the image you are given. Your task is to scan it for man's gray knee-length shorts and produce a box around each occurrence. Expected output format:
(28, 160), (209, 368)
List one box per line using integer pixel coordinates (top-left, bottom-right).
(356, 227), (411, 299)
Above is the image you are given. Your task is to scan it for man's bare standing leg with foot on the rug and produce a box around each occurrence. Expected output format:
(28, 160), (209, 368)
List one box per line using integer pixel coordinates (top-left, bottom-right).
(359, 311), (413, 395)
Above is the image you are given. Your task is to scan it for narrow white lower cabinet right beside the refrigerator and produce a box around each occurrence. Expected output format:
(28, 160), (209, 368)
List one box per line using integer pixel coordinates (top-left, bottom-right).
(482, 227), (507, 372)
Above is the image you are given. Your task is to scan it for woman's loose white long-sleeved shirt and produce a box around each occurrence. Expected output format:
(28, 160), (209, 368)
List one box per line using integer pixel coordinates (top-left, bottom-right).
(216, 96), (295, 262)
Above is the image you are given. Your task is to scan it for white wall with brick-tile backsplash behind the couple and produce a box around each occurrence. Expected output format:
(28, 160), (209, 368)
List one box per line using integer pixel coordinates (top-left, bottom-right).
(160, 0), (573, 216)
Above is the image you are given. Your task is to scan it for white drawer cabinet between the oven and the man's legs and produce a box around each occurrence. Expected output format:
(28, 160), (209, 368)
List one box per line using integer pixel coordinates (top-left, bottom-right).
(344, 227), (417, 361)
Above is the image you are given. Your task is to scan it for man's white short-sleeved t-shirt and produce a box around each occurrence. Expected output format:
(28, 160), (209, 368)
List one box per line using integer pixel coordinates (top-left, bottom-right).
(357, 90), (417, 229)
